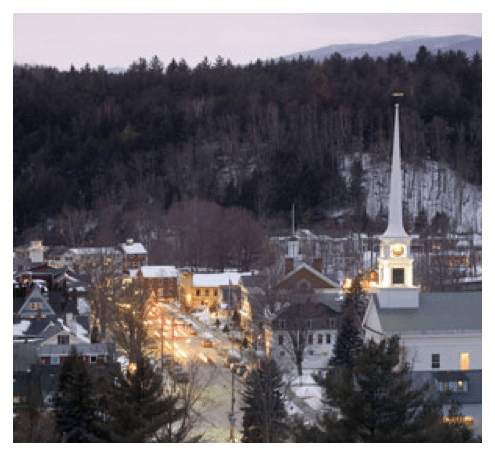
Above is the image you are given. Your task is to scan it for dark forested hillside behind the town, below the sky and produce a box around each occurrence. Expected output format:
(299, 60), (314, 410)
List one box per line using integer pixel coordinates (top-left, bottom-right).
(13, 47), (482, 246)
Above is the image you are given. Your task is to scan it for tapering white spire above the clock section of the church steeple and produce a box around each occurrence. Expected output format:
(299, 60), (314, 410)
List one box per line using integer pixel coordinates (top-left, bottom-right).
(382, 103), (408, 238)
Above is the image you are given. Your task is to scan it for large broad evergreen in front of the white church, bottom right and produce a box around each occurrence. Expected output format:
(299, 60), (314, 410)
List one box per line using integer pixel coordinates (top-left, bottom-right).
(312, 336), (470, 443)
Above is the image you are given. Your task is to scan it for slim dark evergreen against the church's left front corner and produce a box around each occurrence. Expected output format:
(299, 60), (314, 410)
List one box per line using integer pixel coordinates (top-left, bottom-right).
(330, 275), (366, 370)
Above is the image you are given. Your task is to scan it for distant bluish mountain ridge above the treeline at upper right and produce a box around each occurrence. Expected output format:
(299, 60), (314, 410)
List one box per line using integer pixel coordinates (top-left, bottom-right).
(283, 35), (481, 62)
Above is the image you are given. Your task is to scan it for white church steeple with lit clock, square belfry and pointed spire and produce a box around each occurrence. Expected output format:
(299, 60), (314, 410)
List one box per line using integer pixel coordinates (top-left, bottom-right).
(376, 97), (419, 308)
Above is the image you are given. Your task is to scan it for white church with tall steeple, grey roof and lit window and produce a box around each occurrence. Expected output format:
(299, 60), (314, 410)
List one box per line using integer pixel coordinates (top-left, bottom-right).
(362, 99), (482, 435)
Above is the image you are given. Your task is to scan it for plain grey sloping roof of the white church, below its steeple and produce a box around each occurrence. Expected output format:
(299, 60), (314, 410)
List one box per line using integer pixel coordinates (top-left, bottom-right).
(374, 291), (482, 334)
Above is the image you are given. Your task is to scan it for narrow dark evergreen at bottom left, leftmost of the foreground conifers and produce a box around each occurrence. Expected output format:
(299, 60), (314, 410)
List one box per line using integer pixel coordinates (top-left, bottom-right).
(55, 347), (96, 442)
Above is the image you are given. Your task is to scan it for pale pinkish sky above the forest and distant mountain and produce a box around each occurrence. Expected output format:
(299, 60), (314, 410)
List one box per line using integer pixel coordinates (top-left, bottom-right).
(11, 11), (481, 70)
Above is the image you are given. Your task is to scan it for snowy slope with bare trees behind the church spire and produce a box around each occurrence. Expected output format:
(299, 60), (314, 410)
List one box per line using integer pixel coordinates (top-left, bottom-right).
(344, 154), (482, 233)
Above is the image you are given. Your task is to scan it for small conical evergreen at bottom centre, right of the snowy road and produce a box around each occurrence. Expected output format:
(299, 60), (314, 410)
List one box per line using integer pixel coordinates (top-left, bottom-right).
(241, 361), (288, 443)
